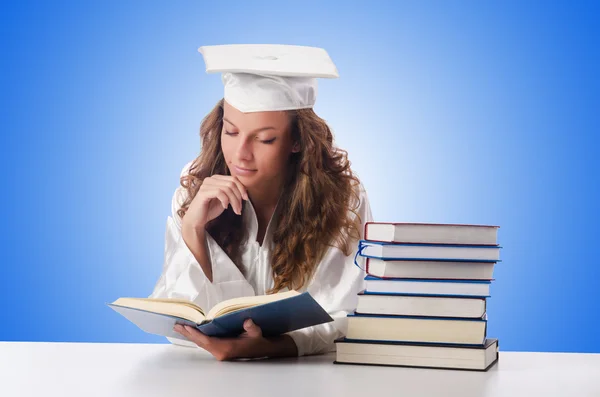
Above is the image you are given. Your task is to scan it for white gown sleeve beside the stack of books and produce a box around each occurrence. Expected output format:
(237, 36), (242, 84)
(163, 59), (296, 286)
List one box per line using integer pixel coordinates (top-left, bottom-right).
(287, 185), (373, 356)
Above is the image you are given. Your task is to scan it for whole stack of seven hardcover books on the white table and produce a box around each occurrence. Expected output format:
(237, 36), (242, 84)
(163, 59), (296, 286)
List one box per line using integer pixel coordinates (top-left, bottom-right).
(335, 222), (501, 371)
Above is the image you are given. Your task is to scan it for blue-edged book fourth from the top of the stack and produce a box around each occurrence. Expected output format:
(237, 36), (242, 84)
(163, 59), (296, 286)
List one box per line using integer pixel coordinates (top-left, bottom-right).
(365, 276), (491, 297)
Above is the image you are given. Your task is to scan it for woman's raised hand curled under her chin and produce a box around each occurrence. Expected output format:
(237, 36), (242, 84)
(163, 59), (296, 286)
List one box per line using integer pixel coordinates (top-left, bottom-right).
(182, 175), (248, 231)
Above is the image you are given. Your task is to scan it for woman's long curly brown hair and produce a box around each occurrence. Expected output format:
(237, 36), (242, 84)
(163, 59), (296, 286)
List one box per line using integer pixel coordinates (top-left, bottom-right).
(177, 99), (362, 293)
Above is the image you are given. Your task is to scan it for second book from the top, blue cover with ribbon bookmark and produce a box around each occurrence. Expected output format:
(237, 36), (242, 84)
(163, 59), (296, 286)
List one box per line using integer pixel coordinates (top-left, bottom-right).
(359, 240), (500, 261)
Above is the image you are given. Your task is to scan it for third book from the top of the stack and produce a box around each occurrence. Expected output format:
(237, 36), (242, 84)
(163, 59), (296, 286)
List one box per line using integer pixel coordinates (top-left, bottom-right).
(366, 258), (495, 280)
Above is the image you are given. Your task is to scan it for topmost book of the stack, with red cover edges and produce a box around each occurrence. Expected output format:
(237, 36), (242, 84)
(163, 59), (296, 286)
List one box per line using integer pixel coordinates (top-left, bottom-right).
(365, 222), (499, 245)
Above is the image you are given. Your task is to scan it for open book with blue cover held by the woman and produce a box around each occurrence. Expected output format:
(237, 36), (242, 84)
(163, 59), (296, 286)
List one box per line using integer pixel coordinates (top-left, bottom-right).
(108, 290), (333, 339)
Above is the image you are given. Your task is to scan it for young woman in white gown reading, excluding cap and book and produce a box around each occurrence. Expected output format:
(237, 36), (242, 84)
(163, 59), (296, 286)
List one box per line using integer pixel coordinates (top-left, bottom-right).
(151, 43), (372, 360)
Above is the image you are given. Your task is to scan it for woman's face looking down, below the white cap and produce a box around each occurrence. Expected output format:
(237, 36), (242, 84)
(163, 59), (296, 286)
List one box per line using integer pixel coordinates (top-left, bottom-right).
(221, 101), (297, 188)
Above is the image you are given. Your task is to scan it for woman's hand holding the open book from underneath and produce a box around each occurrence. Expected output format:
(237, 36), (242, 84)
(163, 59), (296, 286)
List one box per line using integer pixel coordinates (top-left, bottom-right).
(173, 319), (282, 361)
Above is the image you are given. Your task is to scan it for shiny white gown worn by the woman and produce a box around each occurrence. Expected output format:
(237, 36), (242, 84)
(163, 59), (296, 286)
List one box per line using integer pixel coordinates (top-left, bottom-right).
(150, 163), (372, 356)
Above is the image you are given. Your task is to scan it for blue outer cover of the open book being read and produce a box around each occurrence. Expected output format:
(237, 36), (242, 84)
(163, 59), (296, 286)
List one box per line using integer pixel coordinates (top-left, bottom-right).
(108, 292), (333, 340)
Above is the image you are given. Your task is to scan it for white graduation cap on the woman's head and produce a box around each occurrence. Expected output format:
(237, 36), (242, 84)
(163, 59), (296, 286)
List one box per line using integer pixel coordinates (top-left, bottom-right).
(198, 44), (339, 113)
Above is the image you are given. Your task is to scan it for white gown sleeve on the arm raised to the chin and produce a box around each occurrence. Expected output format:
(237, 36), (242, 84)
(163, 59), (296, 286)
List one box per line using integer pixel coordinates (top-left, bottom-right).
(149, 163), (255, 346)
